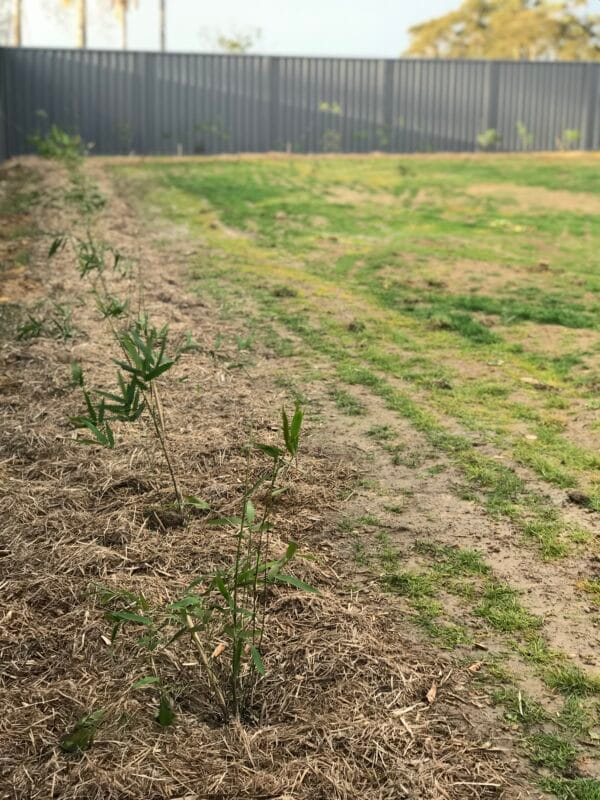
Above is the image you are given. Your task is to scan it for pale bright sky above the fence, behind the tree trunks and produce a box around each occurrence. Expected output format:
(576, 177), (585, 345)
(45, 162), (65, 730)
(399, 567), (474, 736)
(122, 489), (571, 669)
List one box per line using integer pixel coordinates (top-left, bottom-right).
(9, 0), (460, 58)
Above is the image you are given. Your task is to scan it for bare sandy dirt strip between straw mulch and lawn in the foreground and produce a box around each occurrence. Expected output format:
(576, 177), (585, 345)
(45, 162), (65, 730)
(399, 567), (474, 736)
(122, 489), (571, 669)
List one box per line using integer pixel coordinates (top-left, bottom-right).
(328, 387), (600, 672)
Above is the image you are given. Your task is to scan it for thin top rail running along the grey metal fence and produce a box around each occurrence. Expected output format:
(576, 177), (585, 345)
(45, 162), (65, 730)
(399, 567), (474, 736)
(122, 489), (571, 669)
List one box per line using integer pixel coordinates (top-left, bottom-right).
(0, 45), (600, 68)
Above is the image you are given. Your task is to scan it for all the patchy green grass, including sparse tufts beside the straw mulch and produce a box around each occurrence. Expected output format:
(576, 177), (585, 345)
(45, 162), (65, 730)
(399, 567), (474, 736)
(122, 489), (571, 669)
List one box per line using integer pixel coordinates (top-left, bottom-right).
(119, 156), (600, 800)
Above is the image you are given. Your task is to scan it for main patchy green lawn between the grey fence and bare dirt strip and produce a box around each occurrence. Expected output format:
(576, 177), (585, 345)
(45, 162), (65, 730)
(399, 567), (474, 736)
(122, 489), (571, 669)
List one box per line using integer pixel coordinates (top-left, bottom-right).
(119, 157), (600, 528)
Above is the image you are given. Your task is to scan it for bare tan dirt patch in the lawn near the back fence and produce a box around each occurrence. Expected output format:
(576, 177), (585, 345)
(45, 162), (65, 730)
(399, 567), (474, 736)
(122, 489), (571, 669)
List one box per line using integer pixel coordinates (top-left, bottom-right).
(467, 183), (600, 214)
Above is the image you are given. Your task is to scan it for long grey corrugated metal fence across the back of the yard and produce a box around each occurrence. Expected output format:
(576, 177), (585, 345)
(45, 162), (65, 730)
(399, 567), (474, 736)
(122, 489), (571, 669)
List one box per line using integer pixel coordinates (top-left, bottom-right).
(0, 48), (600, 161)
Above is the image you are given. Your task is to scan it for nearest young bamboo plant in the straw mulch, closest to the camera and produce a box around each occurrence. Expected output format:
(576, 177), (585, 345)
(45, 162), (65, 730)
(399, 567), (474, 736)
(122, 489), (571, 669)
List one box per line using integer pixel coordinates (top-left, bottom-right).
(98, 406), (315, 726)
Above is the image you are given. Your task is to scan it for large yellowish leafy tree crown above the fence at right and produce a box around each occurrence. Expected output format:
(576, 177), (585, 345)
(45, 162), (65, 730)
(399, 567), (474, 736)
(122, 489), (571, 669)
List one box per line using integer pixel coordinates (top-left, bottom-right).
(407, 0), (600, 61)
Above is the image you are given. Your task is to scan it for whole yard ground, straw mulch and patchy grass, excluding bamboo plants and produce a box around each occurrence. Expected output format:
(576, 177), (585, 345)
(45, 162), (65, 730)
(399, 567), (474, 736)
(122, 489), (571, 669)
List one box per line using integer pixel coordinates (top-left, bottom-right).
(0, 153), (600, 800)
